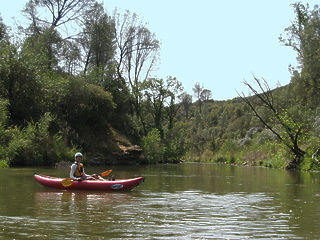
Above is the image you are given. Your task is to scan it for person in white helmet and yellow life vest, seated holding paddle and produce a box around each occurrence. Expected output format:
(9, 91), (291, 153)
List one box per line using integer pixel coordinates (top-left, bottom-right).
(70, 152), (103, 181)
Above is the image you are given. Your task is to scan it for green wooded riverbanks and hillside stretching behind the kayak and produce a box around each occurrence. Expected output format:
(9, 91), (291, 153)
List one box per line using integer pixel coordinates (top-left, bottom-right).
(0, 0), (320, 170)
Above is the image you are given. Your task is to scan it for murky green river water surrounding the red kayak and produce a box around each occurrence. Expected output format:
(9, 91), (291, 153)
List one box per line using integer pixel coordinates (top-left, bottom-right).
(0, 163), (320, 239)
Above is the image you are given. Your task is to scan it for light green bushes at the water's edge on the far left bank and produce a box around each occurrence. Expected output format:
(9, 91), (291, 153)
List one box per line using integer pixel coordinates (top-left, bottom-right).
(0, 96), (75, 166)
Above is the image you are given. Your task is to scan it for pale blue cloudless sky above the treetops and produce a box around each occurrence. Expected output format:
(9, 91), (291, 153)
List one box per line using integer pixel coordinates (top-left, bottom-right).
(0, 0), (318, 100)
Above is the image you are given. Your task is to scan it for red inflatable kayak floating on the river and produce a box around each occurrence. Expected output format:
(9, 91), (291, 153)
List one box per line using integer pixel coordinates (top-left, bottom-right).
(34, 173), (144, 191)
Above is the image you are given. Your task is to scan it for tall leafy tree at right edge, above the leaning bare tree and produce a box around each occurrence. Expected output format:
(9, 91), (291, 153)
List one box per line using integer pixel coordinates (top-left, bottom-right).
(279, 2), (320, 106)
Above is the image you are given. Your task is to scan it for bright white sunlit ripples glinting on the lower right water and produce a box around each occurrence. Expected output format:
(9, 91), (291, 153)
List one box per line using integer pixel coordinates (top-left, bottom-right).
(99, 191), (294, 239)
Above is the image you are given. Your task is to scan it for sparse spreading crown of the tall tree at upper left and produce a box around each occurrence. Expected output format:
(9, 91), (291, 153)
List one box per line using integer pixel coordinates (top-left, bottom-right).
(23, 0), (95, 69)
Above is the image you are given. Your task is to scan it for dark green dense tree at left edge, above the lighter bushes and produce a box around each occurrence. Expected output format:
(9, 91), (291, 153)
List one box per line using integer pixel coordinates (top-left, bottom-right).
(0, 44), (44, 125)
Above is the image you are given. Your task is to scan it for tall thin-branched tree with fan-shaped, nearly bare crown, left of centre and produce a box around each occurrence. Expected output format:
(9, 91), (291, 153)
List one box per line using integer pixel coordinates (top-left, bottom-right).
(114, 11), (160, 135)
